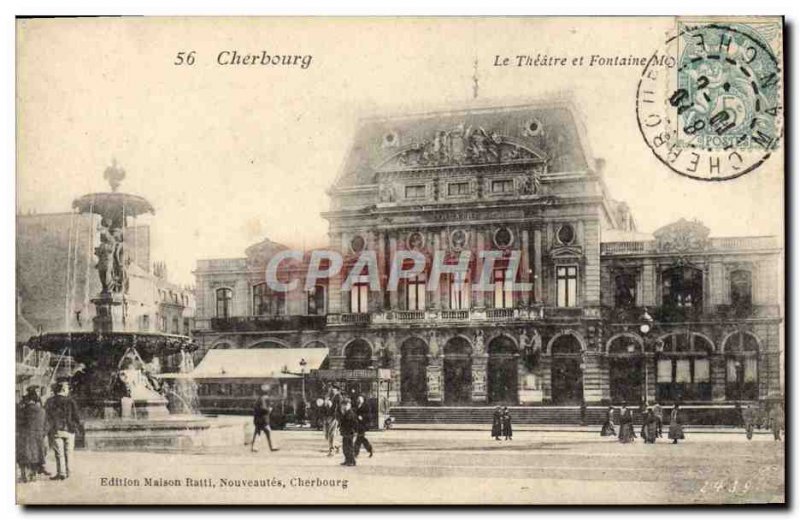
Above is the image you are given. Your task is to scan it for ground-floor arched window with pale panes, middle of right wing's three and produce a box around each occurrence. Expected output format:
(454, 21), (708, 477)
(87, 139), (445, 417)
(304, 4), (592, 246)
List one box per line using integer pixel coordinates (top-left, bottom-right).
(656, 332), (714, 402)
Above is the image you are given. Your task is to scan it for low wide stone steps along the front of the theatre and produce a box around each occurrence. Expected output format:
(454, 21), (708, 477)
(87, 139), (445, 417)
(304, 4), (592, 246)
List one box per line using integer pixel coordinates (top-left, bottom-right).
(389, 405), (739, 427)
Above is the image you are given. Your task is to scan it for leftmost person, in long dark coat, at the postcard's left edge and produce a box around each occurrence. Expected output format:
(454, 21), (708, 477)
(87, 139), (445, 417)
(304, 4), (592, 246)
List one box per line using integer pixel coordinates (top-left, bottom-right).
(17, 386), (49, 482)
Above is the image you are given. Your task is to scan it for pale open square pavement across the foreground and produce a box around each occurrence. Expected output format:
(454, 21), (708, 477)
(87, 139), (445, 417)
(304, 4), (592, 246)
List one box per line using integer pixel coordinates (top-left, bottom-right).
(17, 429), (785, 505)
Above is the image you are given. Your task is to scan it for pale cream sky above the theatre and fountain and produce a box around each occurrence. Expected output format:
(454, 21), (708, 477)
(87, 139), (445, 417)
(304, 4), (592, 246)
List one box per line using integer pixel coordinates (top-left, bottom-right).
(17, 18), (783, 284)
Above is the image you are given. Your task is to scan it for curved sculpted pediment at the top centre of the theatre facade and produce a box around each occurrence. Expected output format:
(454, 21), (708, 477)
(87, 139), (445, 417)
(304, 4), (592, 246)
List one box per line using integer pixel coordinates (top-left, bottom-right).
(378, 124), (546, 171)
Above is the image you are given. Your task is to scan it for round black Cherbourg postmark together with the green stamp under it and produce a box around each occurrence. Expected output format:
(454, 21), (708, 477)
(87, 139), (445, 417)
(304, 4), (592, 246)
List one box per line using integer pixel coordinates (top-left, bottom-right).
(636, 23), (783, 181)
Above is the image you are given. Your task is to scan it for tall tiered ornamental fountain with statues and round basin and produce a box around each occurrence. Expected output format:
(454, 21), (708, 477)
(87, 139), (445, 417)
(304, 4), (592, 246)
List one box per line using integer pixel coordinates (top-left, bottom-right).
(28, 162), (245, 450)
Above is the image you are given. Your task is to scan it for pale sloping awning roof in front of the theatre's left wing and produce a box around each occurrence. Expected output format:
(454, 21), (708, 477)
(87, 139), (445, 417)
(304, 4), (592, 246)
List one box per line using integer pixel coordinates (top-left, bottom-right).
(189, 348), (328, 379)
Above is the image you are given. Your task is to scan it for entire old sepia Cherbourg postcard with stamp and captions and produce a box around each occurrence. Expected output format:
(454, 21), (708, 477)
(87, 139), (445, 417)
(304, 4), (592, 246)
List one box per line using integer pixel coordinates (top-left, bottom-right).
(15, 16), (786, 505)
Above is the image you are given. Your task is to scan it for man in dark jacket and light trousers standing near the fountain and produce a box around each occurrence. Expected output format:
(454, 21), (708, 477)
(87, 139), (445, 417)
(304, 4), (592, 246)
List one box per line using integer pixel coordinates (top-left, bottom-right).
(45, 381), (83, 480)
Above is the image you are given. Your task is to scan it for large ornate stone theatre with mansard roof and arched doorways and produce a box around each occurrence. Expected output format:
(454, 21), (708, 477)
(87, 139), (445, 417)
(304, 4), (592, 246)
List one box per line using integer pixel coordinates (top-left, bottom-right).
(195, 103), (783, 413)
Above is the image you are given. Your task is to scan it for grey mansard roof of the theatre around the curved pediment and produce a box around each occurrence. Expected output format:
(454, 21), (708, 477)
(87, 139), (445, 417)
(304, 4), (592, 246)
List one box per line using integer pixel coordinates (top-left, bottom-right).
(335, 100), (593, 187)
